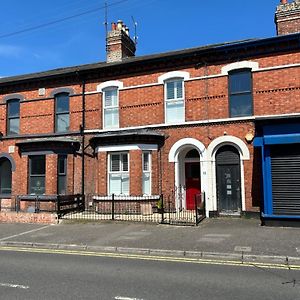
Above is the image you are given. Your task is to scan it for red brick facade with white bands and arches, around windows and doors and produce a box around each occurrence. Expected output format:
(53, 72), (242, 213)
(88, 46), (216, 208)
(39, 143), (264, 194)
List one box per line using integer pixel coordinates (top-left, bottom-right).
(0, 1), (300, 220)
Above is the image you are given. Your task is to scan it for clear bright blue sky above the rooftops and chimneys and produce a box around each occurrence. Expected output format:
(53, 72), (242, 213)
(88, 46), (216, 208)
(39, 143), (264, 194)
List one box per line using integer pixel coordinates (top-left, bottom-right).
(0, 0), (280, 76)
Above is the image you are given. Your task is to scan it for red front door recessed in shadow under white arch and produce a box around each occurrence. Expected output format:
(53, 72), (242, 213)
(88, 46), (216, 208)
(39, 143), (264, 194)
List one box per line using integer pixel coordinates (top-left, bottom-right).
(185, 162), (200, 210)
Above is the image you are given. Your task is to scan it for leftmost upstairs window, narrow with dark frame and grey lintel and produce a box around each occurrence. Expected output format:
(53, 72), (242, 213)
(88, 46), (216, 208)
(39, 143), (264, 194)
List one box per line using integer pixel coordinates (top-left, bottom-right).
(7, 99), (20, 135)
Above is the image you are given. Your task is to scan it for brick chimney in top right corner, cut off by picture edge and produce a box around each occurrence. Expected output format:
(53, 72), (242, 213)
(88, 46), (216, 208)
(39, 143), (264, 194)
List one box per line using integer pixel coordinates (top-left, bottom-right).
(275, 0), (300, 35)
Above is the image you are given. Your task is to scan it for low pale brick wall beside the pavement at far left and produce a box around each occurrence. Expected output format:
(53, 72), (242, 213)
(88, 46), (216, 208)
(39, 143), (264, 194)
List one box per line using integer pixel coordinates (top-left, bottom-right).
(0, 211), (58, 224)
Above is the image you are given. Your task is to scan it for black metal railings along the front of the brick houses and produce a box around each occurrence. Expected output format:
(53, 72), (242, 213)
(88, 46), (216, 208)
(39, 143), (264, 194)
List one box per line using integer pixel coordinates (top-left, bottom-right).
(6, 191), (205, 225)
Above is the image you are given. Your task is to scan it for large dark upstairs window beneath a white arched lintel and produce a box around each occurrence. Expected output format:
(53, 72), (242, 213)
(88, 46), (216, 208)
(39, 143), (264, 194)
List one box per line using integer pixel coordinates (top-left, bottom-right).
(228, 69), (253, 117)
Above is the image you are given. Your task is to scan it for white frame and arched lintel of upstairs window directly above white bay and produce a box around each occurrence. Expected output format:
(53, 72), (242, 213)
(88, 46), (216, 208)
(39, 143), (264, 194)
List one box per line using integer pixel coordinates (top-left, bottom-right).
(97, 80), (123, 129)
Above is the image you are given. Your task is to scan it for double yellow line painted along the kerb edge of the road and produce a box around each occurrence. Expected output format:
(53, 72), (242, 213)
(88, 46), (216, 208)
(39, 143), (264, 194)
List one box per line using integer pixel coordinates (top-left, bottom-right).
(0, 246), (300, 270)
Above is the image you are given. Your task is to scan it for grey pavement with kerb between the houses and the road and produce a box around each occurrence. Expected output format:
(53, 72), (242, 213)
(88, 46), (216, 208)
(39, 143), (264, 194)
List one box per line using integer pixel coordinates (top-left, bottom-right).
(0, 218), (300, 265)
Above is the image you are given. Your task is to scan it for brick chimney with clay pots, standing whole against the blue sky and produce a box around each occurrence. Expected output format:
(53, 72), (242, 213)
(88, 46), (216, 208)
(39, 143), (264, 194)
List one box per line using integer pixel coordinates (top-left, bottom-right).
(106, 20), (136, 62)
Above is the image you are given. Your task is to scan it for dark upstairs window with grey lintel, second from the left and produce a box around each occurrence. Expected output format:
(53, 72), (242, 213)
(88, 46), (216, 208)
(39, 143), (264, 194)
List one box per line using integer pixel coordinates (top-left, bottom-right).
(55, 93), (70, 132)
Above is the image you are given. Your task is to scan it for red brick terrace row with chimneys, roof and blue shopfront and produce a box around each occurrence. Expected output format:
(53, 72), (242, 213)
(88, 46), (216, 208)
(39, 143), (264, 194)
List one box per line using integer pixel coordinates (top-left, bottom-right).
(0, 0), (300, 224)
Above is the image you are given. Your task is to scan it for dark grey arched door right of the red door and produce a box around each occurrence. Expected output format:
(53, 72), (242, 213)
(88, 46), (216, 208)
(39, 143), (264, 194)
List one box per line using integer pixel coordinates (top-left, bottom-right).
(216, 145), (242, 214)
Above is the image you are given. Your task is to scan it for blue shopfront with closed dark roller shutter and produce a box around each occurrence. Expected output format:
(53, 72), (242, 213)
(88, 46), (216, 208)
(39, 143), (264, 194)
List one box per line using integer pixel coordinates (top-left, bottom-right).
(254, 120), (300, 221)
